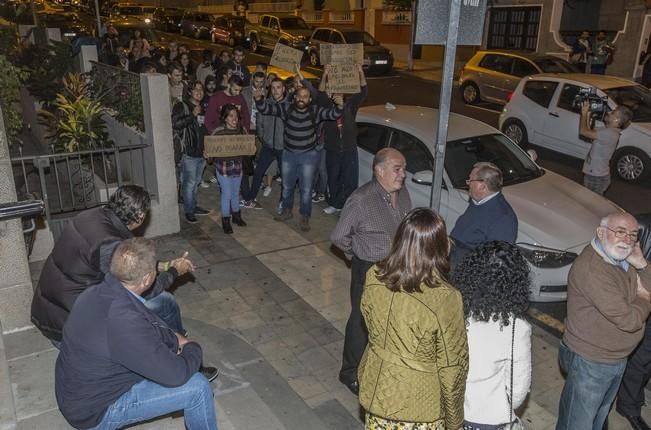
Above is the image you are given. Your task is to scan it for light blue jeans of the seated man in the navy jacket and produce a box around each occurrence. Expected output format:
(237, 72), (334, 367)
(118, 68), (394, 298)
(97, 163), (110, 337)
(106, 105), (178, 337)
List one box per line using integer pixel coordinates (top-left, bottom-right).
(92, 373), (217, 430)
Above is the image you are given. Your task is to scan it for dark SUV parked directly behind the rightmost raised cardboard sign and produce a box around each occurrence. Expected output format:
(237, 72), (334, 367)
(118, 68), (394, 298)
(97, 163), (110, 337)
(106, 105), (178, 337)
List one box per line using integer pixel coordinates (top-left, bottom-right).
(307, 27), (393, 74)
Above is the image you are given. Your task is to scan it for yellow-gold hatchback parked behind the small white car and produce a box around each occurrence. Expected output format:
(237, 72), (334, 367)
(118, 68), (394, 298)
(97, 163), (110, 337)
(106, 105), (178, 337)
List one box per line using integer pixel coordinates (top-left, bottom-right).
(459, 51), (579, 104)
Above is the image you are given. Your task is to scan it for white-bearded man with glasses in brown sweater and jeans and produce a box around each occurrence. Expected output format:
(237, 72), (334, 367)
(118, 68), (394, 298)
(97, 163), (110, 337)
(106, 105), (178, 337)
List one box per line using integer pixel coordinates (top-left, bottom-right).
(556, 213), (651, 430)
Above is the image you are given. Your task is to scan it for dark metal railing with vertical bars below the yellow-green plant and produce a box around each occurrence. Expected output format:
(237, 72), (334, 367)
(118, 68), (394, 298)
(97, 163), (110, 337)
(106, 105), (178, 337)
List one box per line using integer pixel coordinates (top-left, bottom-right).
(11, 145), (148, 221)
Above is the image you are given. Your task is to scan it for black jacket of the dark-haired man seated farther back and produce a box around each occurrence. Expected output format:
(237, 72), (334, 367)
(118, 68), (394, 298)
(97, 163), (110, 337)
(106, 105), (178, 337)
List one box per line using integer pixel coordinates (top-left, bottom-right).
(31, 207), (178, 340)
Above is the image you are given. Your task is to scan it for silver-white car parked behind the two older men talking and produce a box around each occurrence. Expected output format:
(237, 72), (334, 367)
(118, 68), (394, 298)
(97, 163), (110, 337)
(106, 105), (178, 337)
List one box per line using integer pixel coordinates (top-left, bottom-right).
(357, 106), (621, 302)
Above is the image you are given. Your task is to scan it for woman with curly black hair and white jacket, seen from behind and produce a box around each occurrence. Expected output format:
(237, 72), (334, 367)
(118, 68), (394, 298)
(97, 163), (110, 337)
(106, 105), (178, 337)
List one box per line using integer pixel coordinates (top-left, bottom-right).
(452, 241), (531, 430)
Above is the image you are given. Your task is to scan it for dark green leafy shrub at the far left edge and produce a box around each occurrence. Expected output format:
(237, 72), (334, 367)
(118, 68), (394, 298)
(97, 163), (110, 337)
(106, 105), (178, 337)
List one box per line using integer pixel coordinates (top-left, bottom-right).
(0, 55), (25, 145)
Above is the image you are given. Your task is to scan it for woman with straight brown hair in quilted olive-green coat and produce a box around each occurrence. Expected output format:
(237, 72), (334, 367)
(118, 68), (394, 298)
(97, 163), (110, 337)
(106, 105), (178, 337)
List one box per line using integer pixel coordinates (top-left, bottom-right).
(358, 208), (468, 430)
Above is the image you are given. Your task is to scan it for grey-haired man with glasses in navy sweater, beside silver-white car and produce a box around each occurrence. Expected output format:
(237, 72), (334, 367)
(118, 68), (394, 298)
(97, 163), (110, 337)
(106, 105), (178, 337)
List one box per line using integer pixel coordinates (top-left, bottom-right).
(450, 162), (518, 268)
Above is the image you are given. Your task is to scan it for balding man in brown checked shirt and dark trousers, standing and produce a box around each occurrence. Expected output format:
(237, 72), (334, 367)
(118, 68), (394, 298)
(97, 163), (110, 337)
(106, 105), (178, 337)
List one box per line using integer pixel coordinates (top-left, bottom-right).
(330, 148), (411, 395)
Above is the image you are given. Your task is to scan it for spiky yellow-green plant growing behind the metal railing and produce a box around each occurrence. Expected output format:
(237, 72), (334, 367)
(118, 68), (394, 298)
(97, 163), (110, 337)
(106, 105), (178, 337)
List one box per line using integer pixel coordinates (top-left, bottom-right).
(41, 73), (111, 152)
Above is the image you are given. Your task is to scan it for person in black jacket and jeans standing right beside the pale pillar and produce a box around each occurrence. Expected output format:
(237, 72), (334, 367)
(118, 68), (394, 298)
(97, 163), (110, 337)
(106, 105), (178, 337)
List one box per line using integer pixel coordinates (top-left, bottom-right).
(172, 81), (210, 224)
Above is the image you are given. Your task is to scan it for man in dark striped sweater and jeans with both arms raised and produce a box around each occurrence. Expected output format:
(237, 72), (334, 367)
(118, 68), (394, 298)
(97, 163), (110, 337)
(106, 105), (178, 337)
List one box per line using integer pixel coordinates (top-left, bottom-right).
(254, 77), (344, 231)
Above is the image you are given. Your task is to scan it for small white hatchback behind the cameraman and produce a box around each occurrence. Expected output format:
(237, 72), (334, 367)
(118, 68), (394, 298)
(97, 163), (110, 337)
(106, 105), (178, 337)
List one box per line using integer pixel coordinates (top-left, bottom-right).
(499, 74), (651, 183)
